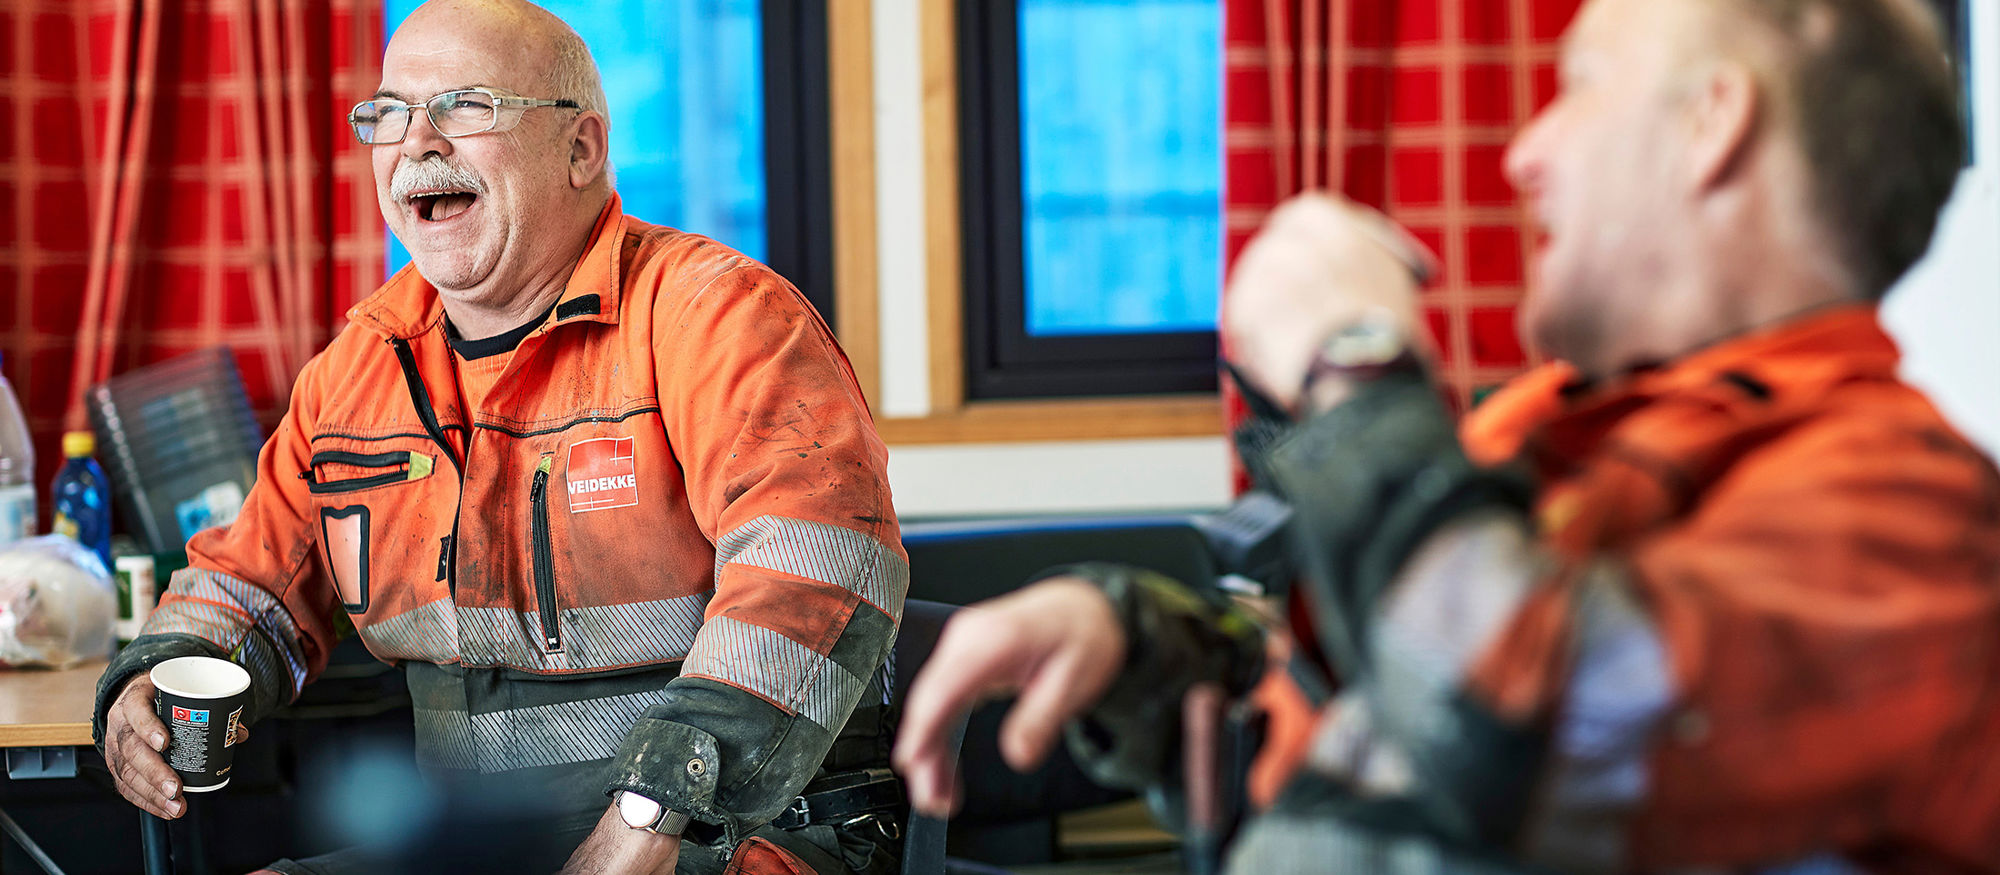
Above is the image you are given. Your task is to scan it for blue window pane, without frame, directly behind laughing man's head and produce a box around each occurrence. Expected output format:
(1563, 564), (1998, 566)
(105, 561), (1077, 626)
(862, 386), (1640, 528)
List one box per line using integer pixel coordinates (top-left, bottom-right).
(382, 0), (766, 272)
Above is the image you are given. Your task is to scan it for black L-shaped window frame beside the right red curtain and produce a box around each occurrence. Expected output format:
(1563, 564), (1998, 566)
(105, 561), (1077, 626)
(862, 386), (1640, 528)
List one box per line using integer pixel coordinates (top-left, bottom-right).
(954, 0), (1220, 400)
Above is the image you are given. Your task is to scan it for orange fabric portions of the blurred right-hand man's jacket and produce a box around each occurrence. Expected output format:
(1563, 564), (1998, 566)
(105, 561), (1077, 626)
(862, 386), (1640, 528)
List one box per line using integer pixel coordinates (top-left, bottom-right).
(1462, 306), (2000, 871)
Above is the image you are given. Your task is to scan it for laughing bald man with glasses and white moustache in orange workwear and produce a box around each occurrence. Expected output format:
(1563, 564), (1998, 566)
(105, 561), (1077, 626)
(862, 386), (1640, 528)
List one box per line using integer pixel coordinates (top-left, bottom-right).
(98, 0), (908, 873)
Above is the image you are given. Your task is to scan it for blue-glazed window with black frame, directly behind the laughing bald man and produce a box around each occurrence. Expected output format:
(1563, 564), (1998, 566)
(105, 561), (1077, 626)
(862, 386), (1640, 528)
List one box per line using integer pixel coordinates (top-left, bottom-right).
(382, 0), (832, 321)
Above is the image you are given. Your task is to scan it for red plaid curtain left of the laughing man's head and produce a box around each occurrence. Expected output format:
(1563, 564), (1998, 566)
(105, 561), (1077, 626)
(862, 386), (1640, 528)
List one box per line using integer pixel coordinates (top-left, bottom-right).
(0, 0), (382, 503)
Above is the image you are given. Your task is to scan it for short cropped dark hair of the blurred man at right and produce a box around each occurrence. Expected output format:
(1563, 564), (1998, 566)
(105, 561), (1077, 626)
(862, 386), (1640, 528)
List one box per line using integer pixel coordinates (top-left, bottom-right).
(1722, 0), (1966, 300)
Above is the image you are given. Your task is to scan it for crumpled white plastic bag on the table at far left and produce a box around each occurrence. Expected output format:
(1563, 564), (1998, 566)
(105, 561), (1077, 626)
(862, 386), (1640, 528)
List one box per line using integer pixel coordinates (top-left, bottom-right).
(0, 535), (118, 669)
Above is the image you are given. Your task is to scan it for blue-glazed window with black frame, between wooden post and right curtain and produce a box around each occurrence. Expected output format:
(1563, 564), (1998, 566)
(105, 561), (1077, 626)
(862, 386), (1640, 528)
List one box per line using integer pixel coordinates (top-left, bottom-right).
(958, 0), (1222, 398)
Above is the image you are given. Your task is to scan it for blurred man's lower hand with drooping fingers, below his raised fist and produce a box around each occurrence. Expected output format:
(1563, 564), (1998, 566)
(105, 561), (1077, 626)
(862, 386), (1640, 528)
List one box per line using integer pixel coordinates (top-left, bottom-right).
(894, 577), (1126, 815)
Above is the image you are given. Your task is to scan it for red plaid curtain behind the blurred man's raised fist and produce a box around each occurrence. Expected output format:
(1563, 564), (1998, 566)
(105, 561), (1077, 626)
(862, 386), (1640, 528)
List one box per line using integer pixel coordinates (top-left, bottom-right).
(1224, 0), (1580, 404)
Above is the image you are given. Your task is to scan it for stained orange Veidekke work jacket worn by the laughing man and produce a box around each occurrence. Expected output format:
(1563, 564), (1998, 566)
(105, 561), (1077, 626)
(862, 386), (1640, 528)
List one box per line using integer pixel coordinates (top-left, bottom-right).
(98, 196), (908, 845)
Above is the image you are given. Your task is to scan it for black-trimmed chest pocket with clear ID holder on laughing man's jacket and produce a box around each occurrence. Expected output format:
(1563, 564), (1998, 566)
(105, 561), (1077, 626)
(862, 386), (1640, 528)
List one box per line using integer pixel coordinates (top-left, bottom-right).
(300, 449), (436, 613)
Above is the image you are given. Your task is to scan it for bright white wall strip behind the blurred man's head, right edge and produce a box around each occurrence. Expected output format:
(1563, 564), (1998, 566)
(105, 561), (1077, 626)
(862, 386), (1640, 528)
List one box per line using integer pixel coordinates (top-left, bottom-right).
(1884, 2), (2000, 455)
